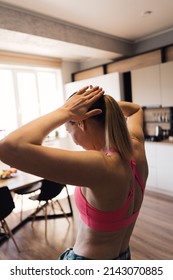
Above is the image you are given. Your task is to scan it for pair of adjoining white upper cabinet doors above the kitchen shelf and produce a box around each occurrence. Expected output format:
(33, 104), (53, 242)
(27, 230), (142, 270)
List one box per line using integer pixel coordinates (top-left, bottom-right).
(131, 62), (173, 107)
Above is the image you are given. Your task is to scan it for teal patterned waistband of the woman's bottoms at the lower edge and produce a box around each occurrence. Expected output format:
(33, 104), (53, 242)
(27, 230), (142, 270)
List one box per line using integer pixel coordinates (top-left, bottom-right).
(59, 248), (131, 260)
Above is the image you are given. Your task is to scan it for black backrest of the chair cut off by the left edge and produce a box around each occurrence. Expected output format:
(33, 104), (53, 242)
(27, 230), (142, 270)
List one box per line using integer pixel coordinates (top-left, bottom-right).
(0, 186), (15, 220)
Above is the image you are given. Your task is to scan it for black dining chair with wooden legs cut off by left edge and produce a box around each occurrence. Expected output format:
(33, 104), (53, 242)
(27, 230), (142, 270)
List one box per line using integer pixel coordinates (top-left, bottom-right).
(0, 186), (20, 252)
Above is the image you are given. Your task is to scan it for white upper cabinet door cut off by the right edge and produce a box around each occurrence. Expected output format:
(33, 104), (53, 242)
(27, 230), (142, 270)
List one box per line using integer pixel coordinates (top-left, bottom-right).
(160, 61), (173, 107)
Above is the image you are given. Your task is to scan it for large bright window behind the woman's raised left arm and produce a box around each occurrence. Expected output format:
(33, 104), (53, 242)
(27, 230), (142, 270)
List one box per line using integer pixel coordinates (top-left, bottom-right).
(0, 65), (64, 138)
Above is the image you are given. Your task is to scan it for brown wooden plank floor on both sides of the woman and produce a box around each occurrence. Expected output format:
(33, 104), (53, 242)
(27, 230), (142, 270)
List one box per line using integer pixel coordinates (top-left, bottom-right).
(0, 188), (173, 260)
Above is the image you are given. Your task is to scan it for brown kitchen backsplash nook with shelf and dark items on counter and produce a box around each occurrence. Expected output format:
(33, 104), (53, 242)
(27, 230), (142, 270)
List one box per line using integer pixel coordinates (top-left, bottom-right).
(143, 107), (173, 141)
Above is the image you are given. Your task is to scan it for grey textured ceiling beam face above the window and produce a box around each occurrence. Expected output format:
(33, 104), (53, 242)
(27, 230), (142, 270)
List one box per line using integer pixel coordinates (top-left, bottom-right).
(0, 3), (133, 56)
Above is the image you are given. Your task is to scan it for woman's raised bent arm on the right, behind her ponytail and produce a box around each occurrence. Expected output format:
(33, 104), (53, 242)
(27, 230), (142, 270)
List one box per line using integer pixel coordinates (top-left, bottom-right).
(118, 101), (144, 142)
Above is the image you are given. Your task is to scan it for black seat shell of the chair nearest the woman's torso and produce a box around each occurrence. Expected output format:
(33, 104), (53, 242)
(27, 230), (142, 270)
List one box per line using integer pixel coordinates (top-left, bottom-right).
(38, 179), (65, 201)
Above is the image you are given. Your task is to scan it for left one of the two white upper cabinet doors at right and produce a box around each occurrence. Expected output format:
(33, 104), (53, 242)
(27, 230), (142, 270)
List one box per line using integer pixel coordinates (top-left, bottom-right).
(131, 65), (161, 106)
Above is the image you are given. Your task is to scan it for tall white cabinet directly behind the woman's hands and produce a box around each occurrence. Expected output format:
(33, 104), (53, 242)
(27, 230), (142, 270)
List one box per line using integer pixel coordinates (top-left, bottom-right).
(65, 72), (124, 101)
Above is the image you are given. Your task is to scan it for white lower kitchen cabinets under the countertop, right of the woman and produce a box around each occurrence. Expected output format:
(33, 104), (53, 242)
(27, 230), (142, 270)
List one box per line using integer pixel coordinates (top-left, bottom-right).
(145, 142), (173, 196)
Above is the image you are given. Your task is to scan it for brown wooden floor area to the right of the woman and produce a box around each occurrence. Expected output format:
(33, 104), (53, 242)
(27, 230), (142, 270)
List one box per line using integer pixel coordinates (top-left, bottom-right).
(131, 191), (173, 260)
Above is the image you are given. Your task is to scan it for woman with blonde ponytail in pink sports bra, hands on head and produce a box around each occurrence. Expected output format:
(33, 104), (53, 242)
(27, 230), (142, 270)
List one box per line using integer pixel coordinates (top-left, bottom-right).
(0, 87), (148, 259)
